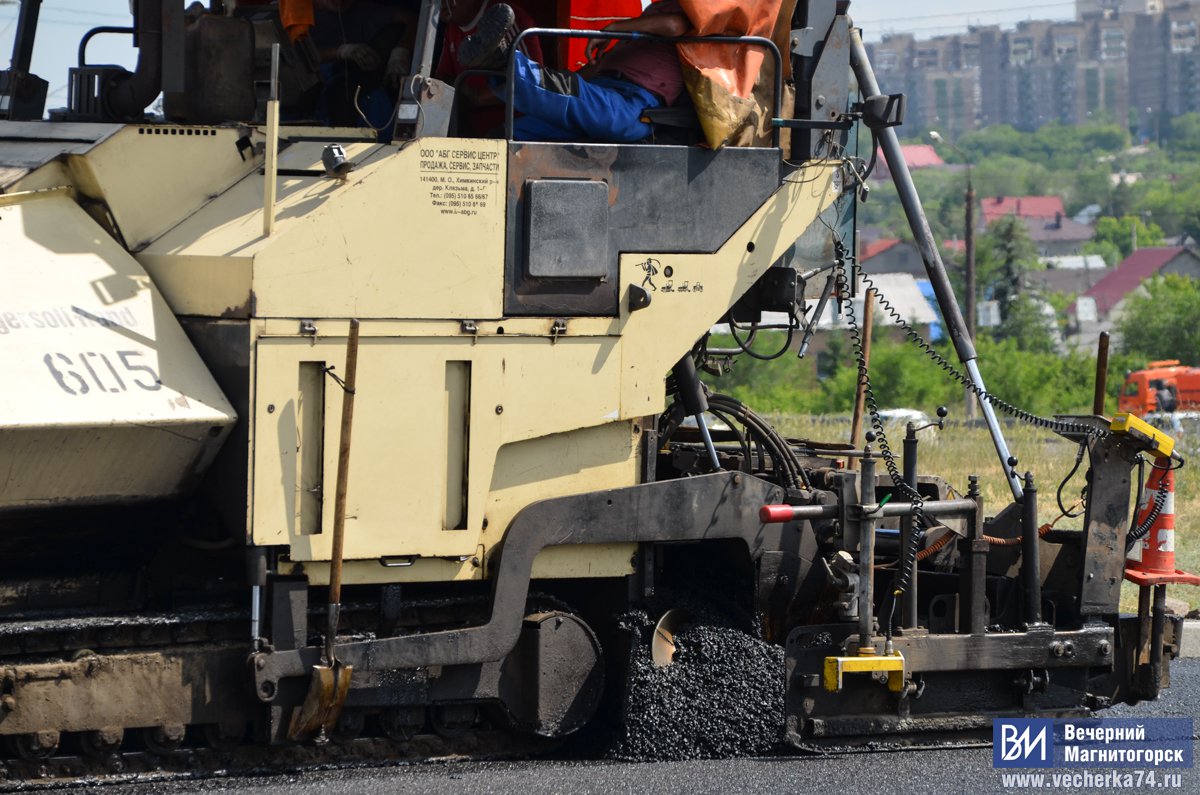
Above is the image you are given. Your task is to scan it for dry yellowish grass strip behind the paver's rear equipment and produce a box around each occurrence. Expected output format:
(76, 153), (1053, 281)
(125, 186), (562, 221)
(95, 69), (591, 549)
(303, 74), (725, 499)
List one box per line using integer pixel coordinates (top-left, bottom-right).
(772, 416), (1200, 610)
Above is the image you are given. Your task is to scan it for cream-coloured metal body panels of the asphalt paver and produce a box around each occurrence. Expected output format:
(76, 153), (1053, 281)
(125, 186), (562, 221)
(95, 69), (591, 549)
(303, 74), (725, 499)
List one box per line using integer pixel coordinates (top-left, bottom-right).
(0, 125), (838, 582)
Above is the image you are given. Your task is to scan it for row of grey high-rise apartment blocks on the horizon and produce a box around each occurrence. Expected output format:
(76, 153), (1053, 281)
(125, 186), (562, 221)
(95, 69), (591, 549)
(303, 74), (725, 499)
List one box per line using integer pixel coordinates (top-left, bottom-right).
(870, 0), (1200, 138)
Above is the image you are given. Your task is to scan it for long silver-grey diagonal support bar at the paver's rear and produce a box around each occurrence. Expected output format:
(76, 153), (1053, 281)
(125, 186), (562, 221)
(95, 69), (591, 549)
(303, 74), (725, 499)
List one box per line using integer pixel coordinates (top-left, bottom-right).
(850, 28), (1022, 502)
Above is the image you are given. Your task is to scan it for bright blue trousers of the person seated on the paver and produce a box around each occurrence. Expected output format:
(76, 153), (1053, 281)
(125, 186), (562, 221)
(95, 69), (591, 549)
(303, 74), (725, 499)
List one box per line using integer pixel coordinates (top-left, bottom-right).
(512, 50), (662, 143)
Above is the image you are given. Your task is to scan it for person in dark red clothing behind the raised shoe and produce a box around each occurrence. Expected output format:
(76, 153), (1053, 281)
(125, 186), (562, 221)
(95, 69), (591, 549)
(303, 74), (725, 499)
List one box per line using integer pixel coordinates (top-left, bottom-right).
(433, 0), (542, 137)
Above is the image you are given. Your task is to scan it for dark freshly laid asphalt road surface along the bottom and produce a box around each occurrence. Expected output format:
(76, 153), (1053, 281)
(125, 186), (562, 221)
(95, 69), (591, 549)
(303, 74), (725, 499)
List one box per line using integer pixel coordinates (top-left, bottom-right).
(76, 659), (1200, 795)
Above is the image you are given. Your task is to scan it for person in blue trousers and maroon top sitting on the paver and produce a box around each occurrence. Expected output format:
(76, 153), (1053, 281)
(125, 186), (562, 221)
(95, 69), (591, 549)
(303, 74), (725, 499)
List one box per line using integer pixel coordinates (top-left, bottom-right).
(458, 0), (691, 143)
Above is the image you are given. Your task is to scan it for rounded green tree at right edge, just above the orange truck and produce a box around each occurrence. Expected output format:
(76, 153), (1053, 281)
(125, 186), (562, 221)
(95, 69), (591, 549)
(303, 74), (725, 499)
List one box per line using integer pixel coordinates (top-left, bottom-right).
(1117, 274), (1200, 364)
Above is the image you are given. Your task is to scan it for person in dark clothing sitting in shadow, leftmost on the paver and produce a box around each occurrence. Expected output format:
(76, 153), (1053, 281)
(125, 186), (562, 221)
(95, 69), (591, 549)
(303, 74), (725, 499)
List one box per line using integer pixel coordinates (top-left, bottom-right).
(311, 0), (416, 128)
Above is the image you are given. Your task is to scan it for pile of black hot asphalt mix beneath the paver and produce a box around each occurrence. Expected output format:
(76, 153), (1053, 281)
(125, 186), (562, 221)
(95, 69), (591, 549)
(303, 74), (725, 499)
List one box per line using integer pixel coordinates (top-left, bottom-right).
(607, 611), (784, 761)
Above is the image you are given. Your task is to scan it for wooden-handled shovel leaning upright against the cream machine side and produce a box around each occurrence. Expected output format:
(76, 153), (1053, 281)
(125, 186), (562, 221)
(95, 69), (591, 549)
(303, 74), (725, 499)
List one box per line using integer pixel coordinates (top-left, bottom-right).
(288, 318), (359, 740)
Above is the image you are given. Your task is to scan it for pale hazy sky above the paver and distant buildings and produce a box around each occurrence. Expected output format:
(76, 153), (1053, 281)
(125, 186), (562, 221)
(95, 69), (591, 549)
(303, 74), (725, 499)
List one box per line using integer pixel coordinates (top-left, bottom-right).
(0, 0), (1075, 108)
